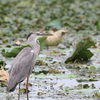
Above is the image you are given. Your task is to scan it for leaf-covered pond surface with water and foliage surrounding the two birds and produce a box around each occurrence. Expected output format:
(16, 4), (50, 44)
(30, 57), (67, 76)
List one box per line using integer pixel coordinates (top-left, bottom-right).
(0, 0), (100, 100)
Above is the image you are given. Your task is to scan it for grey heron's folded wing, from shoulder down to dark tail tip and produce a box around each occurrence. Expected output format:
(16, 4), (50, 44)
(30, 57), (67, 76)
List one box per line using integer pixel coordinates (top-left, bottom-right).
(7, 47), (36, 91)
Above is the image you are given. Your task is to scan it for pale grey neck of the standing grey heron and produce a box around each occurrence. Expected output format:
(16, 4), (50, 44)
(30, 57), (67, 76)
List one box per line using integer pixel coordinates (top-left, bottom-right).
(28, 39), (40, 56)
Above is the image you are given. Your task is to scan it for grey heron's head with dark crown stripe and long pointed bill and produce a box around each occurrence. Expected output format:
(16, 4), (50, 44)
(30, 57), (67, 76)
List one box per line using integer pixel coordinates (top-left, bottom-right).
(27, 31), (53, 40)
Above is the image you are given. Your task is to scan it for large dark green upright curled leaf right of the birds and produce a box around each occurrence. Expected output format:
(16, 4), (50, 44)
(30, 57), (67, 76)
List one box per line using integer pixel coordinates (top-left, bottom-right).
(65, 38), (95, 63)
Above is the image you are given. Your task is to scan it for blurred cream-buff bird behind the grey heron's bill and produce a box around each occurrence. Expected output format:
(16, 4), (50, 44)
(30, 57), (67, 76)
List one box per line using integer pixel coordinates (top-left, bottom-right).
(46, 30), (68, 46)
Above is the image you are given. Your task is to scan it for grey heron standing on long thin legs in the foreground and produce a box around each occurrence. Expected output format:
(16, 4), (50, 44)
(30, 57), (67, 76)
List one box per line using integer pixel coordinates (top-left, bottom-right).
(7, 31), (52, 100)
